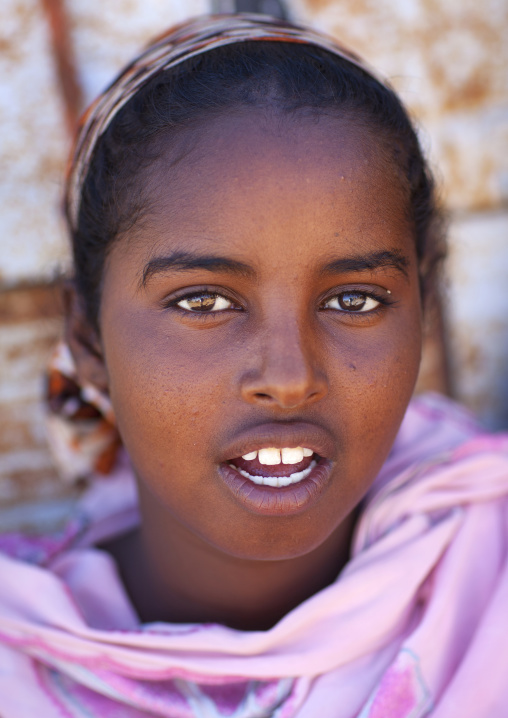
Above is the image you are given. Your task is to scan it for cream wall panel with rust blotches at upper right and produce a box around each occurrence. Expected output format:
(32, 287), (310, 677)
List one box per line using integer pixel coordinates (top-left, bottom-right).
(293, 0), (508, 211)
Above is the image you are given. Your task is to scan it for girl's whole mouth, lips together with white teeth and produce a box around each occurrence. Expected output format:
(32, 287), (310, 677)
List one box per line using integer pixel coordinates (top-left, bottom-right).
(219, 425), (336, 516)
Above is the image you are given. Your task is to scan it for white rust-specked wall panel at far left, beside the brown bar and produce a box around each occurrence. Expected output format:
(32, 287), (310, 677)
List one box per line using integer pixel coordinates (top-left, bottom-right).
(0, 0), (68, 285)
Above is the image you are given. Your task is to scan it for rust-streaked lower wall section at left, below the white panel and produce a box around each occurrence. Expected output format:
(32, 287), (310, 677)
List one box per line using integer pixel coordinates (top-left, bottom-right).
(0, 286), (65, 505)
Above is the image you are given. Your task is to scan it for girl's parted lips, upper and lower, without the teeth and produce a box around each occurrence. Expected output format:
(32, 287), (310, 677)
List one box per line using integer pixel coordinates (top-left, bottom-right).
(218, 422), (337, 516)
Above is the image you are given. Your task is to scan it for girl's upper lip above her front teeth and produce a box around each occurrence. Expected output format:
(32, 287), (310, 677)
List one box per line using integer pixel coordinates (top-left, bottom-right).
(220, 421), (337, 463)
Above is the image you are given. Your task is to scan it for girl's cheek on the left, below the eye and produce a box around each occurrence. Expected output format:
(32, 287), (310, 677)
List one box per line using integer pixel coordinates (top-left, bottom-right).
(104, 312), (243, 475)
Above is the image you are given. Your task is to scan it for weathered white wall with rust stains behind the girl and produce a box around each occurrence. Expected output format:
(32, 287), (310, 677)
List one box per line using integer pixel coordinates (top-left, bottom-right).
(0, 0), (508, 520)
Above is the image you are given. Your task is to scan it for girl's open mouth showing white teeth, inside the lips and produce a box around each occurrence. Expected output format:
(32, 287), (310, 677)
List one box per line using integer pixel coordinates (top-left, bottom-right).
(227, 446), (320, 488)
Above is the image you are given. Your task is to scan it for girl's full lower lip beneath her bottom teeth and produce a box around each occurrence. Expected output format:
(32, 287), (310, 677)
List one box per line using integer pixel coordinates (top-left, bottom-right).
(219, 458), (332, 516)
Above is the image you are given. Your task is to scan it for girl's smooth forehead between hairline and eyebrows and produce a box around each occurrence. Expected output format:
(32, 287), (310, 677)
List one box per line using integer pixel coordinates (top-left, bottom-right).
(122, 109), (413, 268)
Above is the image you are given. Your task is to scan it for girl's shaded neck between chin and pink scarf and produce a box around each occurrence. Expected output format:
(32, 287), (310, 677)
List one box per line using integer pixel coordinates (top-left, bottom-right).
(108, 490), (355, 630)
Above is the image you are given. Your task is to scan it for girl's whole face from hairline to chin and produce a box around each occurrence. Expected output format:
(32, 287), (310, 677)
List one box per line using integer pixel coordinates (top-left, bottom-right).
(94, 110), (421, 559)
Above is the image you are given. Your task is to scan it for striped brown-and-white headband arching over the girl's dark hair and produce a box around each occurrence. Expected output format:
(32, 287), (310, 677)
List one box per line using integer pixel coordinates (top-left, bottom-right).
(65, 14), (386, 230)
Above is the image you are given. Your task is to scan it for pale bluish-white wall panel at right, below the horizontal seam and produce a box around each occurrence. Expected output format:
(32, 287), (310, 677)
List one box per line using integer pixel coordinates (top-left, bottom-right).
(447, 212), (508, 428)
